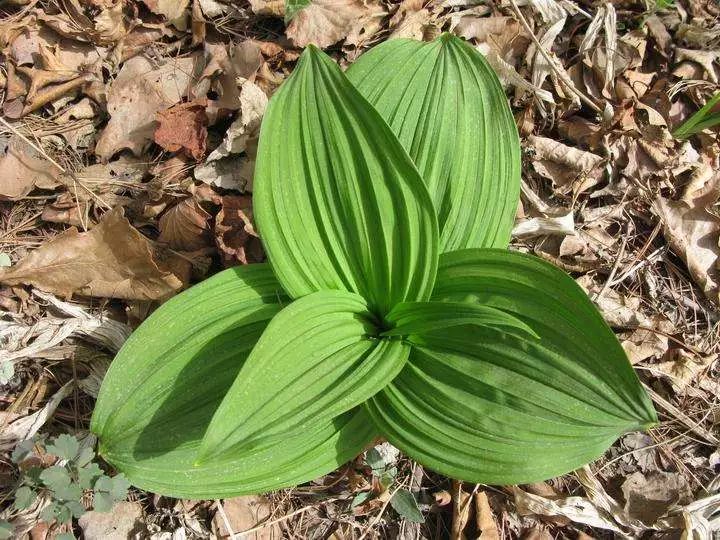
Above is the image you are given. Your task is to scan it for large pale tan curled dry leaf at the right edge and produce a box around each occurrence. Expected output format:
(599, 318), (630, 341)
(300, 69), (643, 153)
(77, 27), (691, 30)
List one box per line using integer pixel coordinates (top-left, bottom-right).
(654, 167), (720, 302)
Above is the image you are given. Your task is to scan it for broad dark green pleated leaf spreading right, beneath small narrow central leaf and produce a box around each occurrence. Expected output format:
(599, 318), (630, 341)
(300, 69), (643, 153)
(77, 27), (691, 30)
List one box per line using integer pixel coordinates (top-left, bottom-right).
(367, 249), (657, 484)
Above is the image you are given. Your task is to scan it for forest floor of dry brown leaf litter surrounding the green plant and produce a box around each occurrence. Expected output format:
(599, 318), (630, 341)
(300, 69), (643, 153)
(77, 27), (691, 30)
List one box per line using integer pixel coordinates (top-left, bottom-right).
(0, 0), (720, 540)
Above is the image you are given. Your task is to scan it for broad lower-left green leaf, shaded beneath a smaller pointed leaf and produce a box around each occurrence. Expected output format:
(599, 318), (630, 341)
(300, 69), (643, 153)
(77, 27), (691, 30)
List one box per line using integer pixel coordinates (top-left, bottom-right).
(91, 264), (373, 498)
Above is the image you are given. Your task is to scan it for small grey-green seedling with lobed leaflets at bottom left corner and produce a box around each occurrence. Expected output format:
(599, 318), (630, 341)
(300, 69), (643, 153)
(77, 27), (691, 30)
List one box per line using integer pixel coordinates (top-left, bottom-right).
(12, 434), (130, 523)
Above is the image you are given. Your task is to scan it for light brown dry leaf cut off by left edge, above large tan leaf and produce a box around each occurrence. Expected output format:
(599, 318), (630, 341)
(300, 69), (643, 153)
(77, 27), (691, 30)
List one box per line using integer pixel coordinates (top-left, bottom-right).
(0, 136), (60, 199)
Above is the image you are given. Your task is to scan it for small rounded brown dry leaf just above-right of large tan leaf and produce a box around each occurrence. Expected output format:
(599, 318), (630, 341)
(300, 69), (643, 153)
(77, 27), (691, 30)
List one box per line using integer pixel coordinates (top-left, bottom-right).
(158, 197), (210, 251)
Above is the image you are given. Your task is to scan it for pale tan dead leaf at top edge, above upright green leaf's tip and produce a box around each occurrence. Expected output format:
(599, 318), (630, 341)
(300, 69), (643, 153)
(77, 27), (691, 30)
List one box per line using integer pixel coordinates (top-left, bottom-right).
(285, 0), (379, 48)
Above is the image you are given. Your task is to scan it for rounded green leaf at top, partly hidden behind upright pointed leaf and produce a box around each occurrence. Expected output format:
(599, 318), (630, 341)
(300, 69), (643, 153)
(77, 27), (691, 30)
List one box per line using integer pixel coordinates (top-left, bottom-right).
(347, 34), (520, 252)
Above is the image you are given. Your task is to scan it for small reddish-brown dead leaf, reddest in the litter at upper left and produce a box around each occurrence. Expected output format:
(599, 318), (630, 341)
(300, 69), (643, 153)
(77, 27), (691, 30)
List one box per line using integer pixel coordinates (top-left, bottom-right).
(155, 100), (208, 160)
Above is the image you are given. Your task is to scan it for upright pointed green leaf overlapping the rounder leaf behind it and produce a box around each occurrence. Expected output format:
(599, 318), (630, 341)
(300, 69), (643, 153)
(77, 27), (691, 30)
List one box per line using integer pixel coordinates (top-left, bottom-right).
(253, 45), (438, 316)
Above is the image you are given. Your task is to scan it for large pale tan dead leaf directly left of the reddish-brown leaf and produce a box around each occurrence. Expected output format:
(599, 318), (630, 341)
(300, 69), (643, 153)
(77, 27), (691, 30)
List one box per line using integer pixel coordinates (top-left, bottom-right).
(95, 56), (197, 160)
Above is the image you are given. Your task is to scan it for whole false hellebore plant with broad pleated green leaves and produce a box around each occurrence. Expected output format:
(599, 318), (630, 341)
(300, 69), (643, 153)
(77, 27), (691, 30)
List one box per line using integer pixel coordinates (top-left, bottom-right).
(92, 35), (656, 498)
